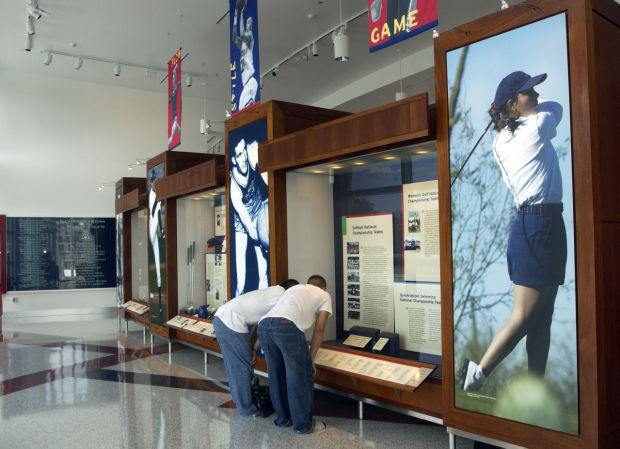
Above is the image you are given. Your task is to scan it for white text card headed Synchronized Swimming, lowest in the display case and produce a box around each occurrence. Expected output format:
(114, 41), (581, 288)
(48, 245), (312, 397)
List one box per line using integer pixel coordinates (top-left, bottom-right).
(394, 282), (441, 355)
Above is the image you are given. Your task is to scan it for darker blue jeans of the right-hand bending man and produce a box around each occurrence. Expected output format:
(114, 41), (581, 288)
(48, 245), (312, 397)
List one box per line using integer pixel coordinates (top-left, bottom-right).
(258, 317), (314, 433)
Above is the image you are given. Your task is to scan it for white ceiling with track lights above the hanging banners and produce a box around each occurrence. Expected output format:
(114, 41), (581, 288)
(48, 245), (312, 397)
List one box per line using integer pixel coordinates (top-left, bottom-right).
(0, 0), (514, 111)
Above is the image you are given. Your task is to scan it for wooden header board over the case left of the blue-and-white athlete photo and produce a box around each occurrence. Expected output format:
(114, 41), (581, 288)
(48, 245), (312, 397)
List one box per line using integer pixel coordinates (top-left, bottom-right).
(155, 156), (226, 200)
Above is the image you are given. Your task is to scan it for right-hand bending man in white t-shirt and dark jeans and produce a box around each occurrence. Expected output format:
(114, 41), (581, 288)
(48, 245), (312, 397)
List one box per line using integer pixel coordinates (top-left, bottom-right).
(258, 275), (332, 434)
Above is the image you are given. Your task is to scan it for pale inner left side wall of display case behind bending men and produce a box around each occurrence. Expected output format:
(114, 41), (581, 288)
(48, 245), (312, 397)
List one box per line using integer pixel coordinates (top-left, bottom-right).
(286, 172), (336, 340)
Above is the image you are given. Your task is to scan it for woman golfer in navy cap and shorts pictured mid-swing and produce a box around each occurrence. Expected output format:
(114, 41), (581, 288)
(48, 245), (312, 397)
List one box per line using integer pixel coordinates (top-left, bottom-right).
(461, 72), (566, 390)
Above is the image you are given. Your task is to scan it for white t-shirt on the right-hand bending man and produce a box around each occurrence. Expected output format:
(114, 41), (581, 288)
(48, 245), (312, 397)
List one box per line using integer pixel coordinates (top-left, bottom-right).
(263, 284), (332, 332)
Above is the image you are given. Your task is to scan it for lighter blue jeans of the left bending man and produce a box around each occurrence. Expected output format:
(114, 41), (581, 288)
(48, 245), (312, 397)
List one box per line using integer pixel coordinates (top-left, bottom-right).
(213, 317), (260, 416)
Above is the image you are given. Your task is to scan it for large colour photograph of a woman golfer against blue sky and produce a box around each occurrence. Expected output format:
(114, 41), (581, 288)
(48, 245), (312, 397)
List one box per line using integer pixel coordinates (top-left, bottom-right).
(448, 14), (579, 434)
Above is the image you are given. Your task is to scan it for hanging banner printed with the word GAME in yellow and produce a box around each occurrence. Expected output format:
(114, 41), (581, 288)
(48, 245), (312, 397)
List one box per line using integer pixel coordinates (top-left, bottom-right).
(368, 0), (438, 53)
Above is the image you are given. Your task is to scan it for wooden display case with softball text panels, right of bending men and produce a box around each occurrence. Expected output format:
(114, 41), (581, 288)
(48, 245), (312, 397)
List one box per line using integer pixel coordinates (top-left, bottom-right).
(259, 95), (442, 422)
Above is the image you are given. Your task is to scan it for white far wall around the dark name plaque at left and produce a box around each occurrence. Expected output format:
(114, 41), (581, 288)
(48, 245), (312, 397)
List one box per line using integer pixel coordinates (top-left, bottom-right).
(0, 70), (226, 313)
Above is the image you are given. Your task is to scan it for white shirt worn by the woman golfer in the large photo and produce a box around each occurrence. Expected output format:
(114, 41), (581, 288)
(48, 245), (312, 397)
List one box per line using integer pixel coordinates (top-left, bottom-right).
(493, 101), (562, 207)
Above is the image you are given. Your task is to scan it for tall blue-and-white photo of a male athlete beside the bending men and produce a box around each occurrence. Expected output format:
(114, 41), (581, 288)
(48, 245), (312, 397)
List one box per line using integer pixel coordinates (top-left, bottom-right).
(227, 118), (269, 298)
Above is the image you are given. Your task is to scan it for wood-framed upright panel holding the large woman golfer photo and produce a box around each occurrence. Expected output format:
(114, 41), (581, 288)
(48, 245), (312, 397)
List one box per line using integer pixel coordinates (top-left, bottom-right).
(435, 0), (619, 448)
